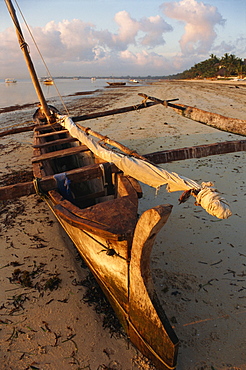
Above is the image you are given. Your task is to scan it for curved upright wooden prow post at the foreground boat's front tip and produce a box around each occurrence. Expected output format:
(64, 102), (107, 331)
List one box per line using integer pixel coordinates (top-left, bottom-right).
(129, 205), (179, 370)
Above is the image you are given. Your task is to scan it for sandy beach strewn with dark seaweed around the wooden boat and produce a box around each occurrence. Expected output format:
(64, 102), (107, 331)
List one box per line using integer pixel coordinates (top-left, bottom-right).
(0, 81), (246, 370)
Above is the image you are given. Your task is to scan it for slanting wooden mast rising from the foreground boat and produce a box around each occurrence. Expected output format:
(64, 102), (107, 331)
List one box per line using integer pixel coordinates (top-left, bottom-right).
(5, 0), (51, 122)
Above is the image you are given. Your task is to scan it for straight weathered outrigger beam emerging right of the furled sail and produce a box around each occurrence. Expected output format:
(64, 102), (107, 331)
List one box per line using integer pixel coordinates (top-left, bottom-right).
(145, 140), (246, 164)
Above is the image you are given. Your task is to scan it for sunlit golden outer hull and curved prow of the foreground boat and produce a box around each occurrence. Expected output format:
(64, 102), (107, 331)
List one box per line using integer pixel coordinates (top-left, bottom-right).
(49, 198), (179, 370)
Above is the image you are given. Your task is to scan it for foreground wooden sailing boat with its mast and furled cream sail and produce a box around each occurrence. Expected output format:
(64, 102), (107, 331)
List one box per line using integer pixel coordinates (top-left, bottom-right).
(3, 0), (234, 370)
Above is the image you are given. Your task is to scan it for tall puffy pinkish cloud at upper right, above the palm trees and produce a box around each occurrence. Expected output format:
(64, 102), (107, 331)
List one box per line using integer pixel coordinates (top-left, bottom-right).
(161, 0), (225, 55)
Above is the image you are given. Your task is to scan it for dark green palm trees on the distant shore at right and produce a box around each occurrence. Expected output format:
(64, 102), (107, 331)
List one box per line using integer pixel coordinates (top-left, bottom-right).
(172, 53), (246, 79)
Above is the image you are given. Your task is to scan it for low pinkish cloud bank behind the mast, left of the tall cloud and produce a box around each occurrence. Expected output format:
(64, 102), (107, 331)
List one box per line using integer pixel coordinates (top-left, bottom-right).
(0, 11), (175, 73)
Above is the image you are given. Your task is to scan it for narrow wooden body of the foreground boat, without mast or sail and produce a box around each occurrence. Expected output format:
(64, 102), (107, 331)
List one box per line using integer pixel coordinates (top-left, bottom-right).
(32, 110), (178, 369)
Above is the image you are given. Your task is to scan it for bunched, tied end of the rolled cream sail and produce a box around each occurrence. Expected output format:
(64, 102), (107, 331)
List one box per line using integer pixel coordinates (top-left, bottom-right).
(196, 182), (232, 219)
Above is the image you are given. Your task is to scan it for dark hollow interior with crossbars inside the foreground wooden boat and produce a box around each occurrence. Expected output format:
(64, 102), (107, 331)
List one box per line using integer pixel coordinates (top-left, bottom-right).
(34, 126), (116, 208)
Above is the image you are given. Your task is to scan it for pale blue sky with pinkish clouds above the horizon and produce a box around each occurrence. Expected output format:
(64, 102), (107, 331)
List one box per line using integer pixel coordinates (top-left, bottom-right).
(0, 0), (246, 78)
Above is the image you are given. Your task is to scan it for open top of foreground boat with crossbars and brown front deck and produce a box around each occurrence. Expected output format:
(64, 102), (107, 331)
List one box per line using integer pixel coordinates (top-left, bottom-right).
(32, 125), (142, 240)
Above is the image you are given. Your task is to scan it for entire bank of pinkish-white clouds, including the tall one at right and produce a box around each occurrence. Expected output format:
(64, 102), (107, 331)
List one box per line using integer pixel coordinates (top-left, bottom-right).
(0, 0), (234, 77)
